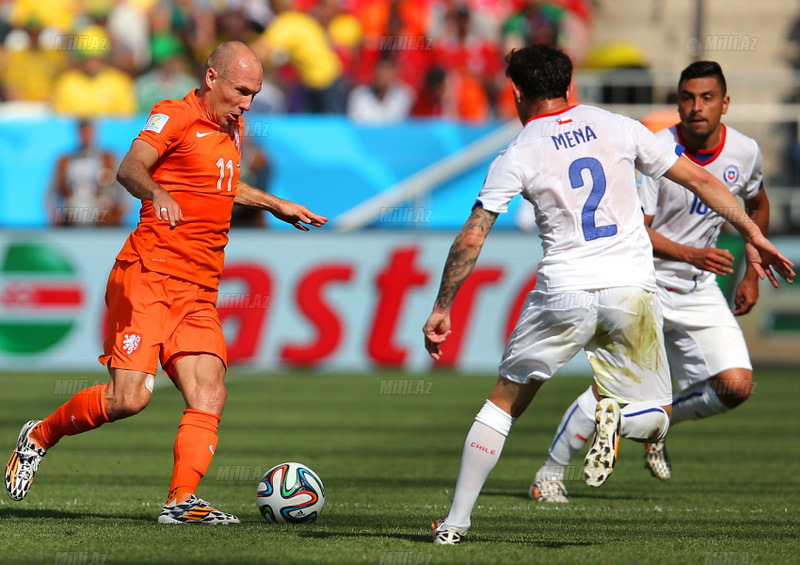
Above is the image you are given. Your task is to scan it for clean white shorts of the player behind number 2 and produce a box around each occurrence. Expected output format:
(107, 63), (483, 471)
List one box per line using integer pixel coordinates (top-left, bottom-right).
(658, 285), (753, 391)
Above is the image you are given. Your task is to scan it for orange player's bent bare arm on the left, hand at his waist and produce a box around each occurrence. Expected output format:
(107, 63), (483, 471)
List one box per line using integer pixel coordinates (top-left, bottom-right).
(117, 139), (183, 228)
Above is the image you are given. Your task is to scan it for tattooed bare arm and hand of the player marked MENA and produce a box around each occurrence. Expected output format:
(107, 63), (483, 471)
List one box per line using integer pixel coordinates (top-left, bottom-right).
(422, 206), (497, 360)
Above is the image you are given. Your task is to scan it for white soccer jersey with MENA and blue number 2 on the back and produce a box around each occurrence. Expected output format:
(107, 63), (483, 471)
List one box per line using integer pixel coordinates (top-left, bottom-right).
(478, 105), (679, 291)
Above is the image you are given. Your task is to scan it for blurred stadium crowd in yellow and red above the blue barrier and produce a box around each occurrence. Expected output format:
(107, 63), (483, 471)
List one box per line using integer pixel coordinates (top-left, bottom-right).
(0, 0), (593, 123)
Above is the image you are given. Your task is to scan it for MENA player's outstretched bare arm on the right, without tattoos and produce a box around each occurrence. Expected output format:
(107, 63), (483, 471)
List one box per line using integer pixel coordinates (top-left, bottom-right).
(664, 155), (795, 287)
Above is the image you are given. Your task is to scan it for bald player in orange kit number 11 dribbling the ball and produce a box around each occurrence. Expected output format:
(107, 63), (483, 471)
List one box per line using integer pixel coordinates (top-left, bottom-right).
(5, 41), (327, 524)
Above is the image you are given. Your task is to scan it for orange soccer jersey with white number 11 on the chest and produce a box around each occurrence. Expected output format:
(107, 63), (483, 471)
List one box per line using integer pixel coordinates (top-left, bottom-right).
(117, 91), (242, 289)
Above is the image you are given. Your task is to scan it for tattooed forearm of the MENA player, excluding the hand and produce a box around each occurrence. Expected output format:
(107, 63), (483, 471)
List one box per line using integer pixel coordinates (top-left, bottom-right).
(436, 206), (497, 309)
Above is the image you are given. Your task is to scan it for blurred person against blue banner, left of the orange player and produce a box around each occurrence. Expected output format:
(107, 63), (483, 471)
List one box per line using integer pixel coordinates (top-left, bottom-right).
(48, 120), (128, 227)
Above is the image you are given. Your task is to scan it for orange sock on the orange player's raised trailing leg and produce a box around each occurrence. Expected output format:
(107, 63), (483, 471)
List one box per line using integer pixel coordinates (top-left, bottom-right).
(36, 385), (110, 449)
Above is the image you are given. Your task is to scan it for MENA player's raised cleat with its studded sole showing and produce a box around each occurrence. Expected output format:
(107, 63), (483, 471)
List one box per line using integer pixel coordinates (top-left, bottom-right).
(583, 398), (622, 487)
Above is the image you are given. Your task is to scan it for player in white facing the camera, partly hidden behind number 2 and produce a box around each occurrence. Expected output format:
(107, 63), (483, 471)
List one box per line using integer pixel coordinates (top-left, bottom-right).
(529, 61), (769, 502)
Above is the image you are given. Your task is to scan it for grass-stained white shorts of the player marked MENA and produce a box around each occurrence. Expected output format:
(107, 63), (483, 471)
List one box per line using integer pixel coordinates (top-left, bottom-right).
(499, 287), (672, 406)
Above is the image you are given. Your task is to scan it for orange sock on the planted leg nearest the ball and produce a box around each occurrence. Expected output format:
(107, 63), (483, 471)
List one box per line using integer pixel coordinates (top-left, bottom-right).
(167, 409), (220, 504)
